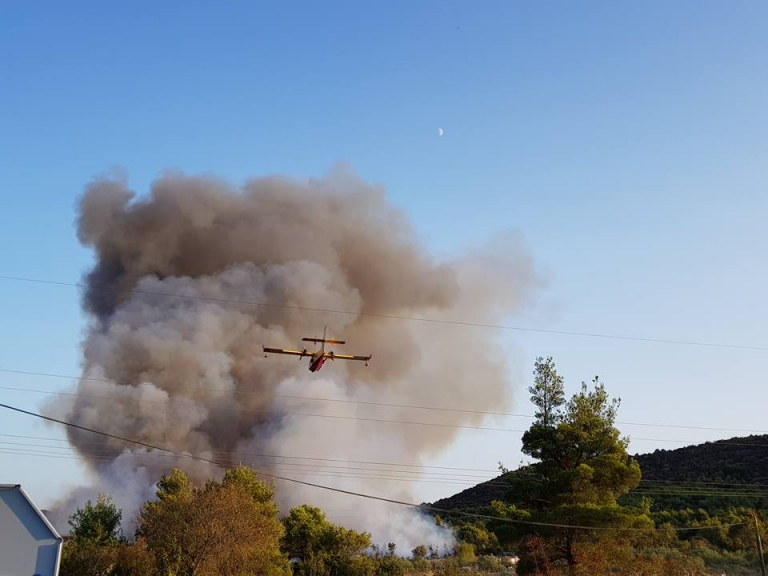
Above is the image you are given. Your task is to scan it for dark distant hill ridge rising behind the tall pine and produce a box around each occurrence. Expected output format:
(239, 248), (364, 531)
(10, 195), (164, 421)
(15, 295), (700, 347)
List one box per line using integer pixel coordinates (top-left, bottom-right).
(431, 435), (768, 510)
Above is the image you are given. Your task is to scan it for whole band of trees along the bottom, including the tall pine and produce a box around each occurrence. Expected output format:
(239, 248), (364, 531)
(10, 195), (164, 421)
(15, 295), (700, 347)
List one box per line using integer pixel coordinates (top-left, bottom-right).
(61, 358), (768, 576)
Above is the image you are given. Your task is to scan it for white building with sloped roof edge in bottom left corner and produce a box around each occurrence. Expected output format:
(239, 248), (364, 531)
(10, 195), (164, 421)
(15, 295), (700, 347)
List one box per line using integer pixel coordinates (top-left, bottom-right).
(0, 484), (62, 576)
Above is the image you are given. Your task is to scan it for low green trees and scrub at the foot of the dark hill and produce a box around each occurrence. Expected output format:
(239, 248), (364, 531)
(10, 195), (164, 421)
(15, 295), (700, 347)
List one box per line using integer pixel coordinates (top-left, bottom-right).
(441, 501), (768, 576)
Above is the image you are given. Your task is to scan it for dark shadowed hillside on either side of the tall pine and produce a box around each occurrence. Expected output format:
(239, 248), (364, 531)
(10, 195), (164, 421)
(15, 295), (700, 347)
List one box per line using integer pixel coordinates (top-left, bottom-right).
(432, 435), (768, 510)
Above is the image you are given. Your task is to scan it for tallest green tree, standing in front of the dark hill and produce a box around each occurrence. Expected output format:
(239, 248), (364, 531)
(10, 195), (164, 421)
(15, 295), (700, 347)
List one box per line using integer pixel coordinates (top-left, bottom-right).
(510, 366), (653, 573)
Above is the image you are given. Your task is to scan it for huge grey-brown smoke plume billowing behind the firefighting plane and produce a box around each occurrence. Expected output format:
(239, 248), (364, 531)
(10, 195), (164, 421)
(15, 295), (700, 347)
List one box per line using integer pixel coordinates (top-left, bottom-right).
(46, 164), (537, 551)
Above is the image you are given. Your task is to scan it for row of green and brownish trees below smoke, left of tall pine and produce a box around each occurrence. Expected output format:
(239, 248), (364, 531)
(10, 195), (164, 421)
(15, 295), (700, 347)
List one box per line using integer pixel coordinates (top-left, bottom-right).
(60, 466), (496, 576)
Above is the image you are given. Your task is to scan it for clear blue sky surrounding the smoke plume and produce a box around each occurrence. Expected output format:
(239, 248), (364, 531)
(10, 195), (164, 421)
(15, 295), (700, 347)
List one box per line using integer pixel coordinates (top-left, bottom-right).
(0, 0), (768, 503)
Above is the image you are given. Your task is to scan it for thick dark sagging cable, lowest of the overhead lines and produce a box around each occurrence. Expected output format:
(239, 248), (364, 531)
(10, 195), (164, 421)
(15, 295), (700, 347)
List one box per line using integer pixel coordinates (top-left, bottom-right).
(0, 403), (745, 532)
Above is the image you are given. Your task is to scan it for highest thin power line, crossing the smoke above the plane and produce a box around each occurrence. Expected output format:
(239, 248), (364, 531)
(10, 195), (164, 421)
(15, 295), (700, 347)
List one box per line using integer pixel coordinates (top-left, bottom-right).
(0, 275), (768, 351)
